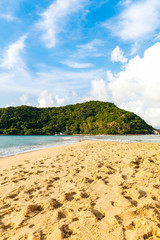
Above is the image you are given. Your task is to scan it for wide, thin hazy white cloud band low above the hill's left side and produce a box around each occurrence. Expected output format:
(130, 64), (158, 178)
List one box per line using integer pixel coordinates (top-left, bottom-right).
(0, 52), (105, 99)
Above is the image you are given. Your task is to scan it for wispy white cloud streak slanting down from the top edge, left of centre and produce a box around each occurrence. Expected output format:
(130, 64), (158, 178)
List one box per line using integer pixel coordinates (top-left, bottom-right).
(37, 0), (86, 48)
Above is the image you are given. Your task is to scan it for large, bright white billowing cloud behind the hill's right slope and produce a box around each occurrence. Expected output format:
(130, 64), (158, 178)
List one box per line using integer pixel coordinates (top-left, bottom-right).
(107, 43), (160, 127)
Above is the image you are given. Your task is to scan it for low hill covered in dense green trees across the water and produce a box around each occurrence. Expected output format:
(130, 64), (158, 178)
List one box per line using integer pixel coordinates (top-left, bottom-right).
(0, 101), (153, 135)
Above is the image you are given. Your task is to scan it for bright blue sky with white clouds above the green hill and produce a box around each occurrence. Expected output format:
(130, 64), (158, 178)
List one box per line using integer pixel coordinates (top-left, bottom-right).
(0, 0), (160, 127)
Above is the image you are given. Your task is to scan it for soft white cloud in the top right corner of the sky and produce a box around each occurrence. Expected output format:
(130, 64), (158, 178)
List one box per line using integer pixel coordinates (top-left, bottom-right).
(104, 0), (160, 41)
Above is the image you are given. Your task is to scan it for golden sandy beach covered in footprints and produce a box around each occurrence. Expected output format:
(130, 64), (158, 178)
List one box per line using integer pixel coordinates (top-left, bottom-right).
(0, 141), (160, 240)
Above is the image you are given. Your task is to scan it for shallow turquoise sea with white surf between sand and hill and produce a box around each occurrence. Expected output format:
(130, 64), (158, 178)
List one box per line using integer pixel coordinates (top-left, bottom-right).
(0, 135), (160, 158)
